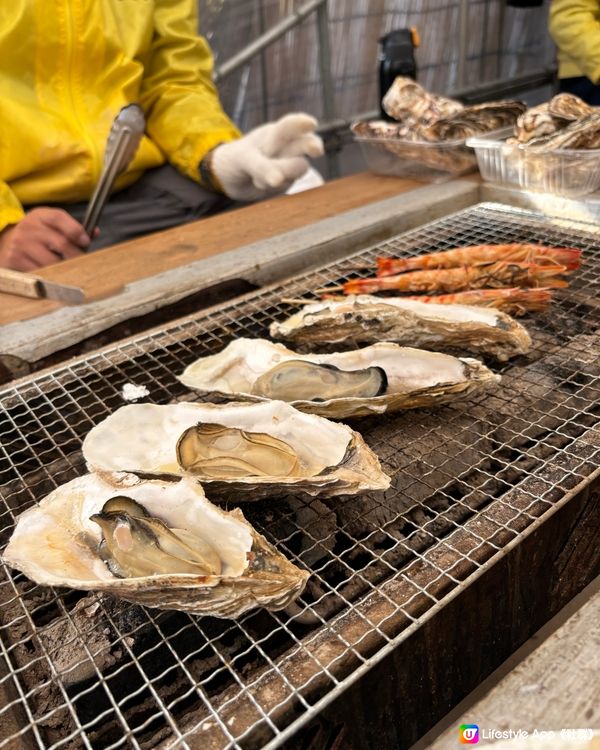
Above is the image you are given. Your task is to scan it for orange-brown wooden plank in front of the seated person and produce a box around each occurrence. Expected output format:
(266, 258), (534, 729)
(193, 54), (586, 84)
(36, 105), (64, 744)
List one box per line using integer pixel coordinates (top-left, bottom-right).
(0, 178), (423, 325)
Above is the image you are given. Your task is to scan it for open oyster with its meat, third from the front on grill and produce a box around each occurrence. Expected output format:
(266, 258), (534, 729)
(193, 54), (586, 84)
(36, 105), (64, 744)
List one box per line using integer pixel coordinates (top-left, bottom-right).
(179, 338), (499, 419)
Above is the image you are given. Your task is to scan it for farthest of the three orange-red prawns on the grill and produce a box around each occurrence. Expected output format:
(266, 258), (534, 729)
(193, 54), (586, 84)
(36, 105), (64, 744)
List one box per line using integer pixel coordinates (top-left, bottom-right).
(377, 242), (581, 276)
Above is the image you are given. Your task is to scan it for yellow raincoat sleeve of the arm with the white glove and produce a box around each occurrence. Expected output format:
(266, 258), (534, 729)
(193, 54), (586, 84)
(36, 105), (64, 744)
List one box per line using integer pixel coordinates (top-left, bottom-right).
(140, 0), (240, 182)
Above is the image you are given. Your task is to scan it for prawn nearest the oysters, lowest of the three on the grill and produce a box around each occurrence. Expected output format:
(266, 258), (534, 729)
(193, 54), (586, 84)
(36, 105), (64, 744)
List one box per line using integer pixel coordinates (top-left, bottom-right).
(406, 287), (552, 315)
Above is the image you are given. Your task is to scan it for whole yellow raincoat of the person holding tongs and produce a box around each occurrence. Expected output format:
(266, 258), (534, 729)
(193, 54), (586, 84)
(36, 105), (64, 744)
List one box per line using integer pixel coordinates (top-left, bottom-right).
(0, 0), (239, 230)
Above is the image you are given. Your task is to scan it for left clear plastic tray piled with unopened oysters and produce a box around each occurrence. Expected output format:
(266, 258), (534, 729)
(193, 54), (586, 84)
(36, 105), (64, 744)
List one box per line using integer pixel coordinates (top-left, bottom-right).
(351, 76), (525, 182)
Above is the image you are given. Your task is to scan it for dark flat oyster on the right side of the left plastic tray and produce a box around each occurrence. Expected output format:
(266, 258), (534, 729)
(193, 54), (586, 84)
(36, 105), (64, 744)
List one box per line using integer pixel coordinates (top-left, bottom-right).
(420, 101), (526, 143)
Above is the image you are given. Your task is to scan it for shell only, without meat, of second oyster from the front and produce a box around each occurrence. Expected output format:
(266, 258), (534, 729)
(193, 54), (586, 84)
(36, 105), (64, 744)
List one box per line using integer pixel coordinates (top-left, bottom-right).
(83, 401), (390, 502)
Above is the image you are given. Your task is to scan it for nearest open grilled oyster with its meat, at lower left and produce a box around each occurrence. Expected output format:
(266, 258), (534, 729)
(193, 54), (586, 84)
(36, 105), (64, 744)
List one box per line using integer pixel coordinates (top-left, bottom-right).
(4, 474), (308, 617)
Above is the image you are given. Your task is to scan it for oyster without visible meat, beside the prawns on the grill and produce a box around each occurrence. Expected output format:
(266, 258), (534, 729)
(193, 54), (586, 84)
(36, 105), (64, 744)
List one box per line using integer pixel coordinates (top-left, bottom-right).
(270, 294), (531, 360)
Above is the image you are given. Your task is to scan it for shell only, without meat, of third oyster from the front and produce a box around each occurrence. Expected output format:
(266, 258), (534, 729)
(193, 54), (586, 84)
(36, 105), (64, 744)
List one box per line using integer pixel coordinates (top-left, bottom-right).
(179, 338), (500, 419)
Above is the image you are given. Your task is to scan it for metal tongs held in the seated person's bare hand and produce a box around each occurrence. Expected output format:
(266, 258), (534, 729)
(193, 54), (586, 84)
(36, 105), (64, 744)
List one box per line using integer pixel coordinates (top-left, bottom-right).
(83, 104), (146, 237)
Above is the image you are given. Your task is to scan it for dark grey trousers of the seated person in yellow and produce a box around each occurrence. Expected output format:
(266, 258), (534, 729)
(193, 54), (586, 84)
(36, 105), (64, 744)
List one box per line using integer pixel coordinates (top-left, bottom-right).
(27, 164), (235, 251)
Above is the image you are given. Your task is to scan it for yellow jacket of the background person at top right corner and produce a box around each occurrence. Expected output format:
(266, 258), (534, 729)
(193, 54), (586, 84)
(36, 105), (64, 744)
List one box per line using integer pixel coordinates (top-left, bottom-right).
(548, 0), (600, 83)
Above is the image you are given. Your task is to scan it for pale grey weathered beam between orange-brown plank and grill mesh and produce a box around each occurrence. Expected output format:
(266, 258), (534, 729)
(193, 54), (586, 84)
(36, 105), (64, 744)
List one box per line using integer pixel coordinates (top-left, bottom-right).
(0, 181), (479, 363)
